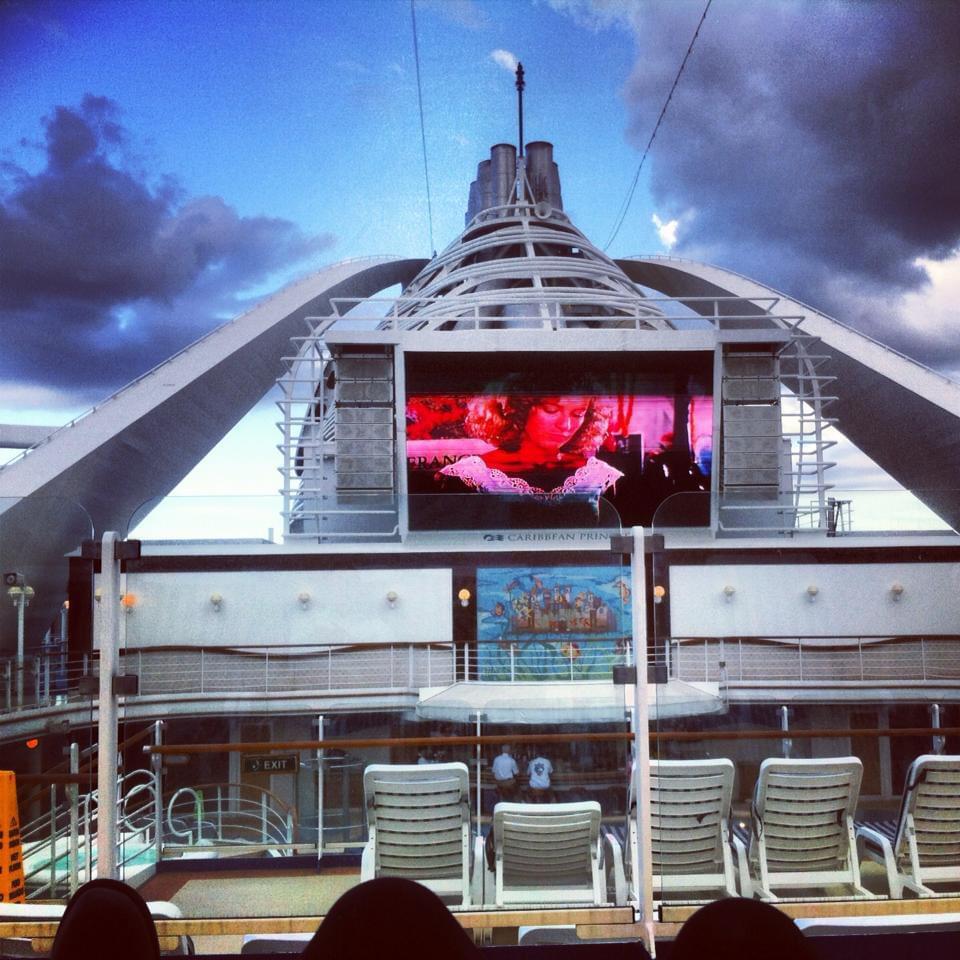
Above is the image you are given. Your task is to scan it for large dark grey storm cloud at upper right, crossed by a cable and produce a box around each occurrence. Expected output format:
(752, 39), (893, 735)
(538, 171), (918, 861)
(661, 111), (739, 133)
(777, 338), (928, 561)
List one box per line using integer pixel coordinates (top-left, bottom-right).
(616, 0), (960, 356)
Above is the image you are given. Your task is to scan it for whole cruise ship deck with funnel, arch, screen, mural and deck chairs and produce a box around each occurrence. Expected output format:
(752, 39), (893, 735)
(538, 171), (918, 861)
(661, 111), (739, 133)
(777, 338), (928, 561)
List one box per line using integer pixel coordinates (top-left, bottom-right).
(0, 118), (960, 957)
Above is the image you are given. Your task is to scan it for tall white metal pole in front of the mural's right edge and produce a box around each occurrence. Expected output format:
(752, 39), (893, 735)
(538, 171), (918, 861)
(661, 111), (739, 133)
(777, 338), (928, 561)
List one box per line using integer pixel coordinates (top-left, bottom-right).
(630, 527), (655, 955)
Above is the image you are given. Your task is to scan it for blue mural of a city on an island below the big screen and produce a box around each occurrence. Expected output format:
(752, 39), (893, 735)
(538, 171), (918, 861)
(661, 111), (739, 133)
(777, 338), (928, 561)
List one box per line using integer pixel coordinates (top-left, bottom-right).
(477, 566), (631, 681)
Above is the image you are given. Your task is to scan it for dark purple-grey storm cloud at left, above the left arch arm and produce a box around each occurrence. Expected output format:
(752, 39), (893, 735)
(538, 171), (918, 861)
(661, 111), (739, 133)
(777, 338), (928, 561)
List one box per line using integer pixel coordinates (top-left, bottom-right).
(0, 95), (331, 389)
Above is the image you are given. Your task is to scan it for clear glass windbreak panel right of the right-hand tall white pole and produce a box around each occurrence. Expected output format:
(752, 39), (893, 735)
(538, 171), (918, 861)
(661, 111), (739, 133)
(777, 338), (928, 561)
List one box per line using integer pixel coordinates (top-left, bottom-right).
(649, 491), (960, 919)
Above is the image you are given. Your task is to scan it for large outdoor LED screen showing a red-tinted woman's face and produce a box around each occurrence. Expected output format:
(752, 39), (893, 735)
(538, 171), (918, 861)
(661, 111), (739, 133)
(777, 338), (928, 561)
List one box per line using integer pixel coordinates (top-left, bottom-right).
(406, 353), (713, 530)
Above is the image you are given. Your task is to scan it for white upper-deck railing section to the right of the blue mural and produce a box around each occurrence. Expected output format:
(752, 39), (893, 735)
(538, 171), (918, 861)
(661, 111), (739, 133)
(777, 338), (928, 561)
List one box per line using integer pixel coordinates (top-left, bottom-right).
(670, 635), (960, 685)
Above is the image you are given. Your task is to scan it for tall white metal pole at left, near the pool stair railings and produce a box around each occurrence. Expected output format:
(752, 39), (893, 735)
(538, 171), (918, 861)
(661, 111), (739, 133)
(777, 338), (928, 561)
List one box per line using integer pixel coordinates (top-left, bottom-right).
(96, 530), (120, 880)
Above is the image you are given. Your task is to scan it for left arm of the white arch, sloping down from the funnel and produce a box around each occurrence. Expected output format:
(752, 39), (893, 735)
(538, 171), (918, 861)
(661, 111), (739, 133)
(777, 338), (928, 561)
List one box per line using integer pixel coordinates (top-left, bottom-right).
(0, 257), (427, 651)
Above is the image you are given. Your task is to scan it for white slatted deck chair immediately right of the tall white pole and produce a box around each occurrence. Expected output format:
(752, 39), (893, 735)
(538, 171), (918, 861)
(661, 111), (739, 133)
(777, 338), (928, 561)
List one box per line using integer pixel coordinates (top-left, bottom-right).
(605, 759), (753, 903)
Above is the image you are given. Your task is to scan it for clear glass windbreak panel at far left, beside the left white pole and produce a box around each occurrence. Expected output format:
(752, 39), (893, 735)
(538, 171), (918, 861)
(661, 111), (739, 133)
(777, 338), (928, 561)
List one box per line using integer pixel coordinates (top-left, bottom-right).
(0, 496), (99, 899)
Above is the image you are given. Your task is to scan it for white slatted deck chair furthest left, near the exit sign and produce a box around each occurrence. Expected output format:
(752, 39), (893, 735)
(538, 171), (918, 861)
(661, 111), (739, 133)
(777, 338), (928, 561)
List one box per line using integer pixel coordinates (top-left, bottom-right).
(360, 763), (483, 907)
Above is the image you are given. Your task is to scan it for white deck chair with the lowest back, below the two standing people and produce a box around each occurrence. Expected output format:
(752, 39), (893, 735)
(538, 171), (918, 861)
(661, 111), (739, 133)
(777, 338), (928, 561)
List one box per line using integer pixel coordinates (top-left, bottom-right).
(493, 800), (606, 907)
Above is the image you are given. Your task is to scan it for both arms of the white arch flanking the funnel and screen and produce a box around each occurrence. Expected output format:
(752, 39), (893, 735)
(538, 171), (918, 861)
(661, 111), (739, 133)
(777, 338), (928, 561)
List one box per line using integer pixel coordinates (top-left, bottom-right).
(0, 248), (960, 650)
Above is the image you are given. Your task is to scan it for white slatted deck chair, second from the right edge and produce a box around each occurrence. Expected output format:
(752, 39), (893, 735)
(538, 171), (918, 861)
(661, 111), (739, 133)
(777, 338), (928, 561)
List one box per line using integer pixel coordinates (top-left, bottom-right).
(750, 757), (874, 900)
